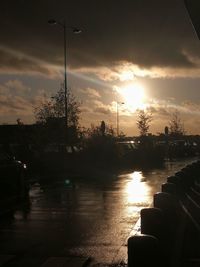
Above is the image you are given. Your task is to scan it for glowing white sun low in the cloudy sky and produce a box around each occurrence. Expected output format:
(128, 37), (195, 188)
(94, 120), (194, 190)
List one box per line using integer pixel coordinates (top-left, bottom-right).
(117, 83), (146, 112)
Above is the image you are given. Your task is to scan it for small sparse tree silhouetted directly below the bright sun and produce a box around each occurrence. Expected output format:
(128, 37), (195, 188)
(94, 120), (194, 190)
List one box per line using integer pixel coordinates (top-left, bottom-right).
(137, 110), (152, 136)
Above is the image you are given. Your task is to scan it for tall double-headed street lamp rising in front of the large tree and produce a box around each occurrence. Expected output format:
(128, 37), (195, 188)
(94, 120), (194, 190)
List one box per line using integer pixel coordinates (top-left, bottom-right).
(48, 19), (81, 142)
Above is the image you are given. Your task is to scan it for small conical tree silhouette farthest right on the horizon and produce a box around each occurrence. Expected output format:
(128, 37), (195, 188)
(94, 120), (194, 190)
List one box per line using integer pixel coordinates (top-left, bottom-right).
(169, 110), (185, 137)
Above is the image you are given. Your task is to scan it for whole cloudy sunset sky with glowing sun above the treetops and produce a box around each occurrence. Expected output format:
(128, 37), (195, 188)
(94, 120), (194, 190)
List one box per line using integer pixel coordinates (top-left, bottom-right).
(0, 0), (200, 135)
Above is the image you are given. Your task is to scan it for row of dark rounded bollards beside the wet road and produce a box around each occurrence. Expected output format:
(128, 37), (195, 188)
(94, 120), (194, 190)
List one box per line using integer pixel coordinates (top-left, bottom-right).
(128, 161), (200, 267)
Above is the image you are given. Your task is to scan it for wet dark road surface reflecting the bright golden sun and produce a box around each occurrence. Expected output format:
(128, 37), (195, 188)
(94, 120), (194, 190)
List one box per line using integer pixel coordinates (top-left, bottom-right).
(0, 160), (197, 267)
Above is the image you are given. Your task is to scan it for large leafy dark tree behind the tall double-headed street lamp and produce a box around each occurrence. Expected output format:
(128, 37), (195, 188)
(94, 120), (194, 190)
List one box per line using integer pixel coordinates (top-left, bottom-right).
(34, 87), (81, 144)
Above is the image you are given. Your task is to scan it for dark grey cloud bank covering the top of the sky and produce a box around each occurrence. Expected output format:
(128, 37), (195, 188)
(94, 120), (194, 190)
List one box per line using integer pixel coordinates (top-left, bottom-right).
(0, 0), (200, 75)
